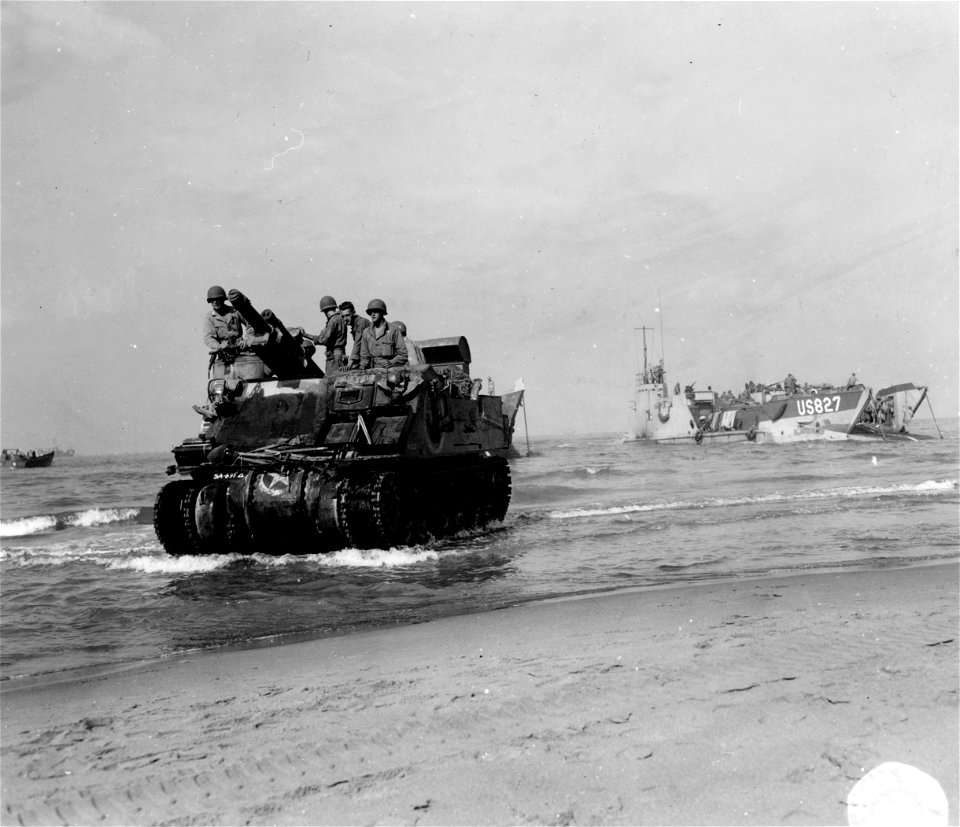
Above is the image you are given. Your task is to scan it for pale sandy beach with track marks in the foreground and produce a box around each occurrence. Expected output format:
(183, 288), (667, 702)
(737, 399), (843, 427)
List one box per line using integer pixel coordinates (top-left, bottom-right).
(0, 564), (960, 824)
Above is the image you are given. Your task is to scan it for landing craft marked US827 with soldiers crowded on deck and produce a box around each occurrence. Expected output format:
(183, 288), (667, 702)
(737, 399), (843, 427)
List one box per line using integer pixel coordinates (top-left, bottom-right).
(625, 328), (929, 444)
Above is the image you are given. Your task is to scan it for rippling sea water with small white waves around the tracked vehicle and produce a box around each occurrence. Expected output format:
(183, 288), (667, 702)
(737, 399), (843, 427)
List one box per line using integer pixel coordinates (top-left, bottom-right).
(0, 420), (960, 680)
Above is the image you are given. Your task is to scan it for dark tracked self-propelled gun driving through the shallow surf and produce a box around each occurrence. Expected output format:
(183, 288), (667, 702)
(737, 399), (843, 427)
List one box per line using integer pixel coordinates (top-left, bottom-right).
(153, 290), (513, 555)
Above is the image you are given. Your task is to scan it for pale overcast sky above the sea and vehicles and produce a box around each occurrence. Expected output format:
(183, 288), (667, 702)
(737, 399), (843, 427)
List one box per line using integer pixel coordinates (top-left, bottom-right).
(0, 2), (960, 452)
